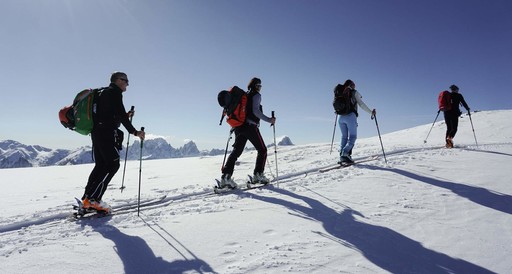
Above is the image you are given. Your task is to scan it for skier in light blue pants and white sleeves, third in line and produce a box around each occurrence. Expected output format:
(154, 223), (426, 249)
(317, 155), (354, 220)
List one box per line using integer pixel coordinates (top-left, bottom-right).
(338, 79), (377, 164)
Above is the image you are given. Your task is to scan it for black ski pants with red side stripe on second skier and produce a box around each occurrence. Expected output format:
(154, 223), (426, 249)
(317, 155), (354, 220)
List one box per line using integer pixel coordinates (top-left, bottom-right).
(222, 124), (267, 174)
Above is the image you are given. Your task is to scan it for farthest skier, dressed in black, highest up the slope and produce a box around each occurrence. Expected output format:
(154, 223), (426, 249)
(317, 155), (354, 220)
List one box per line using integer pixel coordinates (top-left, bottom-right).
(444, 85), (469, 148)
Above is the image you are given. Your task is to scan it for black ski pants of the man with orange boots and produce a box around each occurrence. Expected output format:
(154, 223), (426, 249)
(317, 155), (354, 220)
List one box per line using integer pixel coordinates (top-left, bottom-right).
(82, 128), (122, 201)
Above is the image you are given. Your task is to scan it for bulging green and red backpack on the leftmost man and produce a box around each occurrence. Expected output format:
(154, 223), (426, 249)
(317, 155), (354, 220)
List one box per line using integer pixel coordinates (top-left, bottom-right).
(59, 88), (105, 135)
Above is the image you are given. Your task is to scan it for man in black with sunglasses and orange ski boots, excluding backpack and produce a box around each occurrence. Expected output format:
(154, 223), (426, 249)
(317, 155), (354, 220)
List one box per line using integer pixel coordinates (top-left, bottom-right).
(82, 72), (145, 213)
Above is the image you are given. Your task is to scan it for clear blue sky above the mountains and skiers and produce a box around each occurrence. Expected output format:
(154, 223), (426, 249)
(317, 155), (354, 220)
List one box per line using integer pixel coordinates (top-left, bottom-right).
(0, 0), (512, 149)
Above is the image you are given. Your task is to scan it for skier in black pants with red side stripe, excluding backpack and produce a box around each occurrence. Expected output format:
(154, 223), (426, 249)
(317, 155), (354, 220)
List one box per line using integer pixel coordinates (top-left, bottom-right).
(220, 77), (276, 188)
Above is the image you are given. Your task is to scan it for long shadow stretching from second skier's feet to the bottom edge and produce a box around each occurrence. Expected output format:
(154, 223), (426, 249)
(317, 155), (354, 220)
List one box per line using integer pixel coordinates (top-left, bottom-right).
(251, 187), (493, 273)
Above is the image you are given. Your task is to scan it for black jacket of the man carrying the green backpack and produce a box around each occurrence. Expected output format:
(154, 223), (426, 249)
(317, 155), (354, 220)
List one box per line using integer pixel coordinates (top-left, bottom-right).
(93, 83), (137, 134)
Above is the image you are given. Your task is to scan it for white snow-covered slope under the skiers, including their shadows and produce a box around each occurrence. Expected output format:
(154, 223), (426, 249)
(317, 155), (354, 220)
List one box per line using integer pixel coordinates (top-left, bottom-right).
(0, 110), (512, 273)
